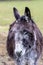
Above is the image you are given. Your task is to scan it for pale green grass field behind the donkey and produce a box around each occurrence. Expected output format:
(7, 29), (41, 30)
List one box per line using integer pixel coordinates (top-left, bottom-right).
(0, 0), (43, 33)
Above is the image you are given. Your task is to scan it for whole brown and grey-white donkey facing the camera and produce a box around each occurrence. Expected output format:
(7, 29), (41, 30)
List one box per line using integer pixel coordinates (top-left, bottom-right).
(7, 7), (43, 65)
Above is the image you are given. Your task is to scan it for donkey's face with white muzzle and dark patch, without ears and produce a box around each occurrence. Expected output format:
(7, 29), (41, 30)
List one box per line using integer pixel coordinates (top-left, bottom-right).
(13, 24), (34, 57)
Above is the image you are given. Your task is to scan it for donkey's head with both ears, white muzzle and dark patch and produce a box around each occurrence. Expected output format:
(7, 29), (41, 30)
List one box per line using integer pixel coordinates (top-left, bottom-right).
(11, 8), (35, 58)
